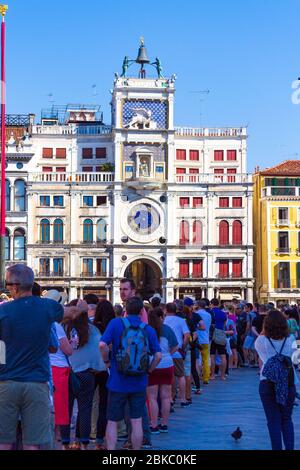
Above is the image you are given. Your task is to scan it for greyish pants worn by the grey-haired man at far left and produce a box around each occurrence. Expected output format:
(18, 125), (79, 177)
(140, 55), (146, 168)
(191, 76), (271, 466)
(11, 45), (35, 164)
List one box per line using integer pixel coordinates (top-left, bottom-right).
(0, 381), (51, 446)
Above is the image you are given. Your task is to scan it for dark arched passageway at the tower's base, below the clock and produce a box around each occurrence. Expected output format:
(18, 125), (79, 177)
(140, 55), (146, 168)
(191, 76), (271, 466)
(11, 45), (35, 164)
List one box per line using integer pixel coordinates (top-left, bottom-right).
(125, 258), (162, 300)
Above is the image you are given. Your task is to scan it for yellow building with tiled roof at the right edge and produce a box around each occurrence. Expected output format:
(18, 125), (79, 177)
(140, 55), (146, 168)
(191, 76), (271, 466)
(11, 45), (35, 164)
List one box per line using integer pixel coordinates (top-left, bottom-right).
(253, 160), (300, 305)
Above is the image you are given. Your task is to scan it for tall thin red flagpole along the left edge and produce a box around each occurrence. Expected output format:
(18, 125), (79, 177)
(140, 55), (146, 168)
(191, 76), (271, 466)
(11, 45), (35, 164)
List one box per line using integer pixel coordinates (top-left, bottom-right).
(0, 4), (8, 289)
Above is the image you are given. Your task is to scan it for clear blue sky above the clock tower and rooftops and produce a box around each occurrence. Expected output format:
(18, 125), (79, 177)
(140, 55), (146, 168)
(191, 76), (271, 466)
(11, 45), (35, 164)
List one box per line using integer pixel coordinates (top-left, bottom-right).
(7, 0), (300, 171)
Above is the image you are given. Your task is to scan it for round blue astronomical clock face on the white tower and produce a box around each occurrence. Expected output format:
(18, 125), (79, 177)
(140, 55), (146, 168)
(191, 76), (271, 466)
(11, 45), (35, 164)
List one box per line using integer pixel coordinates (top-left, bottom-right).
(128, 204), (160, 235)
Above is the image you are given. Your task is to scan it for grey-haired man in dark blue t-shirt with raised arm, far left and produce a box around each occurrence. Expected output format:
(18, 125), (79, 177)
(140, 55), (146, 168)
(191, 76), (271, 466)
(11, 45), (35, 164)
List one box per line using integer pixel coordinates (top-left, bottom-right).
(0, 265), (64, 450)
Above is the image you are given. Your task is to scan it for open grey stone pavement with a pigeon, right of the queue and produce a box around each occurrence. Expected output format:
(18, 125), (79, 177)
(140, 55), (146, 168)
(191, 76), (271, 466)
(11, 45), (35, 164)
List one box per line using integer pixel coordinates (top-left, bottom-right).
(152, 369), (300, 450)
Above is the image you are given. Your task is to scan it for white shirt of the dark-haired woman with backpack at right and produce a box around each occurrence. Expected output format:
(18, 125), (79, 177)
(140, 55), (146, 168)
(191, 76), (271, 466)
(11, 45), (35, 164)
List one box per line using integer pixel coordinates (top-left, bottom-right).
(255, 336), (298, 384)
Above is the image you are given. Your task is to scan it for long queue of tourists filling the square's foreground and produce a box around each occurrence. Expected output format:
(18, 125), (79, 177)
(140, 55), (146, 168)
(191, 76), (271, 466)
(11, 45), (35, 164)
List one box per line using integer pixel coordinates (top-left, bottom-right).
(0, 265), (299, 450)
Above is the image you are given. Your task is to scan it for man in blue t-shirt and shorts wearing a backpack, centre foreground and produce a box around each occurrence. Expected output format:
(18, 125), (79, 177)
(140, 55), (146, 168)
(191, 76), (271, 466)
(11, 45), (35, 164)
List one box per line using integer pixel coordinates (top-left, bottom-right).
(100, 297), (161, 450)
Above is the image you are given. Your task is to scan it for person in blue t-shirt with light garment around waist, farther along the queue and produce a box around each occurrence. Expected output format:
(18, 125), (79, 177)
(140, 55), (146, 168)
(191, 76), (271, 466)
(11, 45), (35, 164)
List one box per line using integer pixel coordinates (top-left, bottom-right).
(210, 299), (227, 380)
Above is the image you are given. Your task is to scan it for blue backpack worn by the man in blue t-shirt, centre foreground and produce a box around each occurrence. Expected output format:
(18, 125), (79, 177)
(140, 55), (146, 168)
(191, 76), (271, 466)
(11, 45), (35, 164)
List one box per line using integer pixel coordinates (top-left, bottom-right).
(116, 318), (150, 376)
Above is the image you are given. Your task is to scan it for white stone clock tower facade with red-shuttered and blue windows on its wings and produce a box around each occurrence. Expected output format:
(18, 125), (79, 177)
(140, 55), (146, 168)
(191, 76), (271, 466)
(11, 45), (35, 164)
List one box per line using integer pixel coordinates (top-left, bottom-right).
(7, 73), (253, 303)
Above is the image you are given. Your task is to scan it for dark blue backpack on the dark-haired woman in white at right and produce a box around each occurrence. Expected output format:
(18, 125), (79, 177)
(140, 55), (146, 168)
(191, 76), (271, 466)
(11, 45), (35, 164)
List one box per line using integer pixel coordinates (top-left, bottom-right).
(263, 338), (294, 405)
